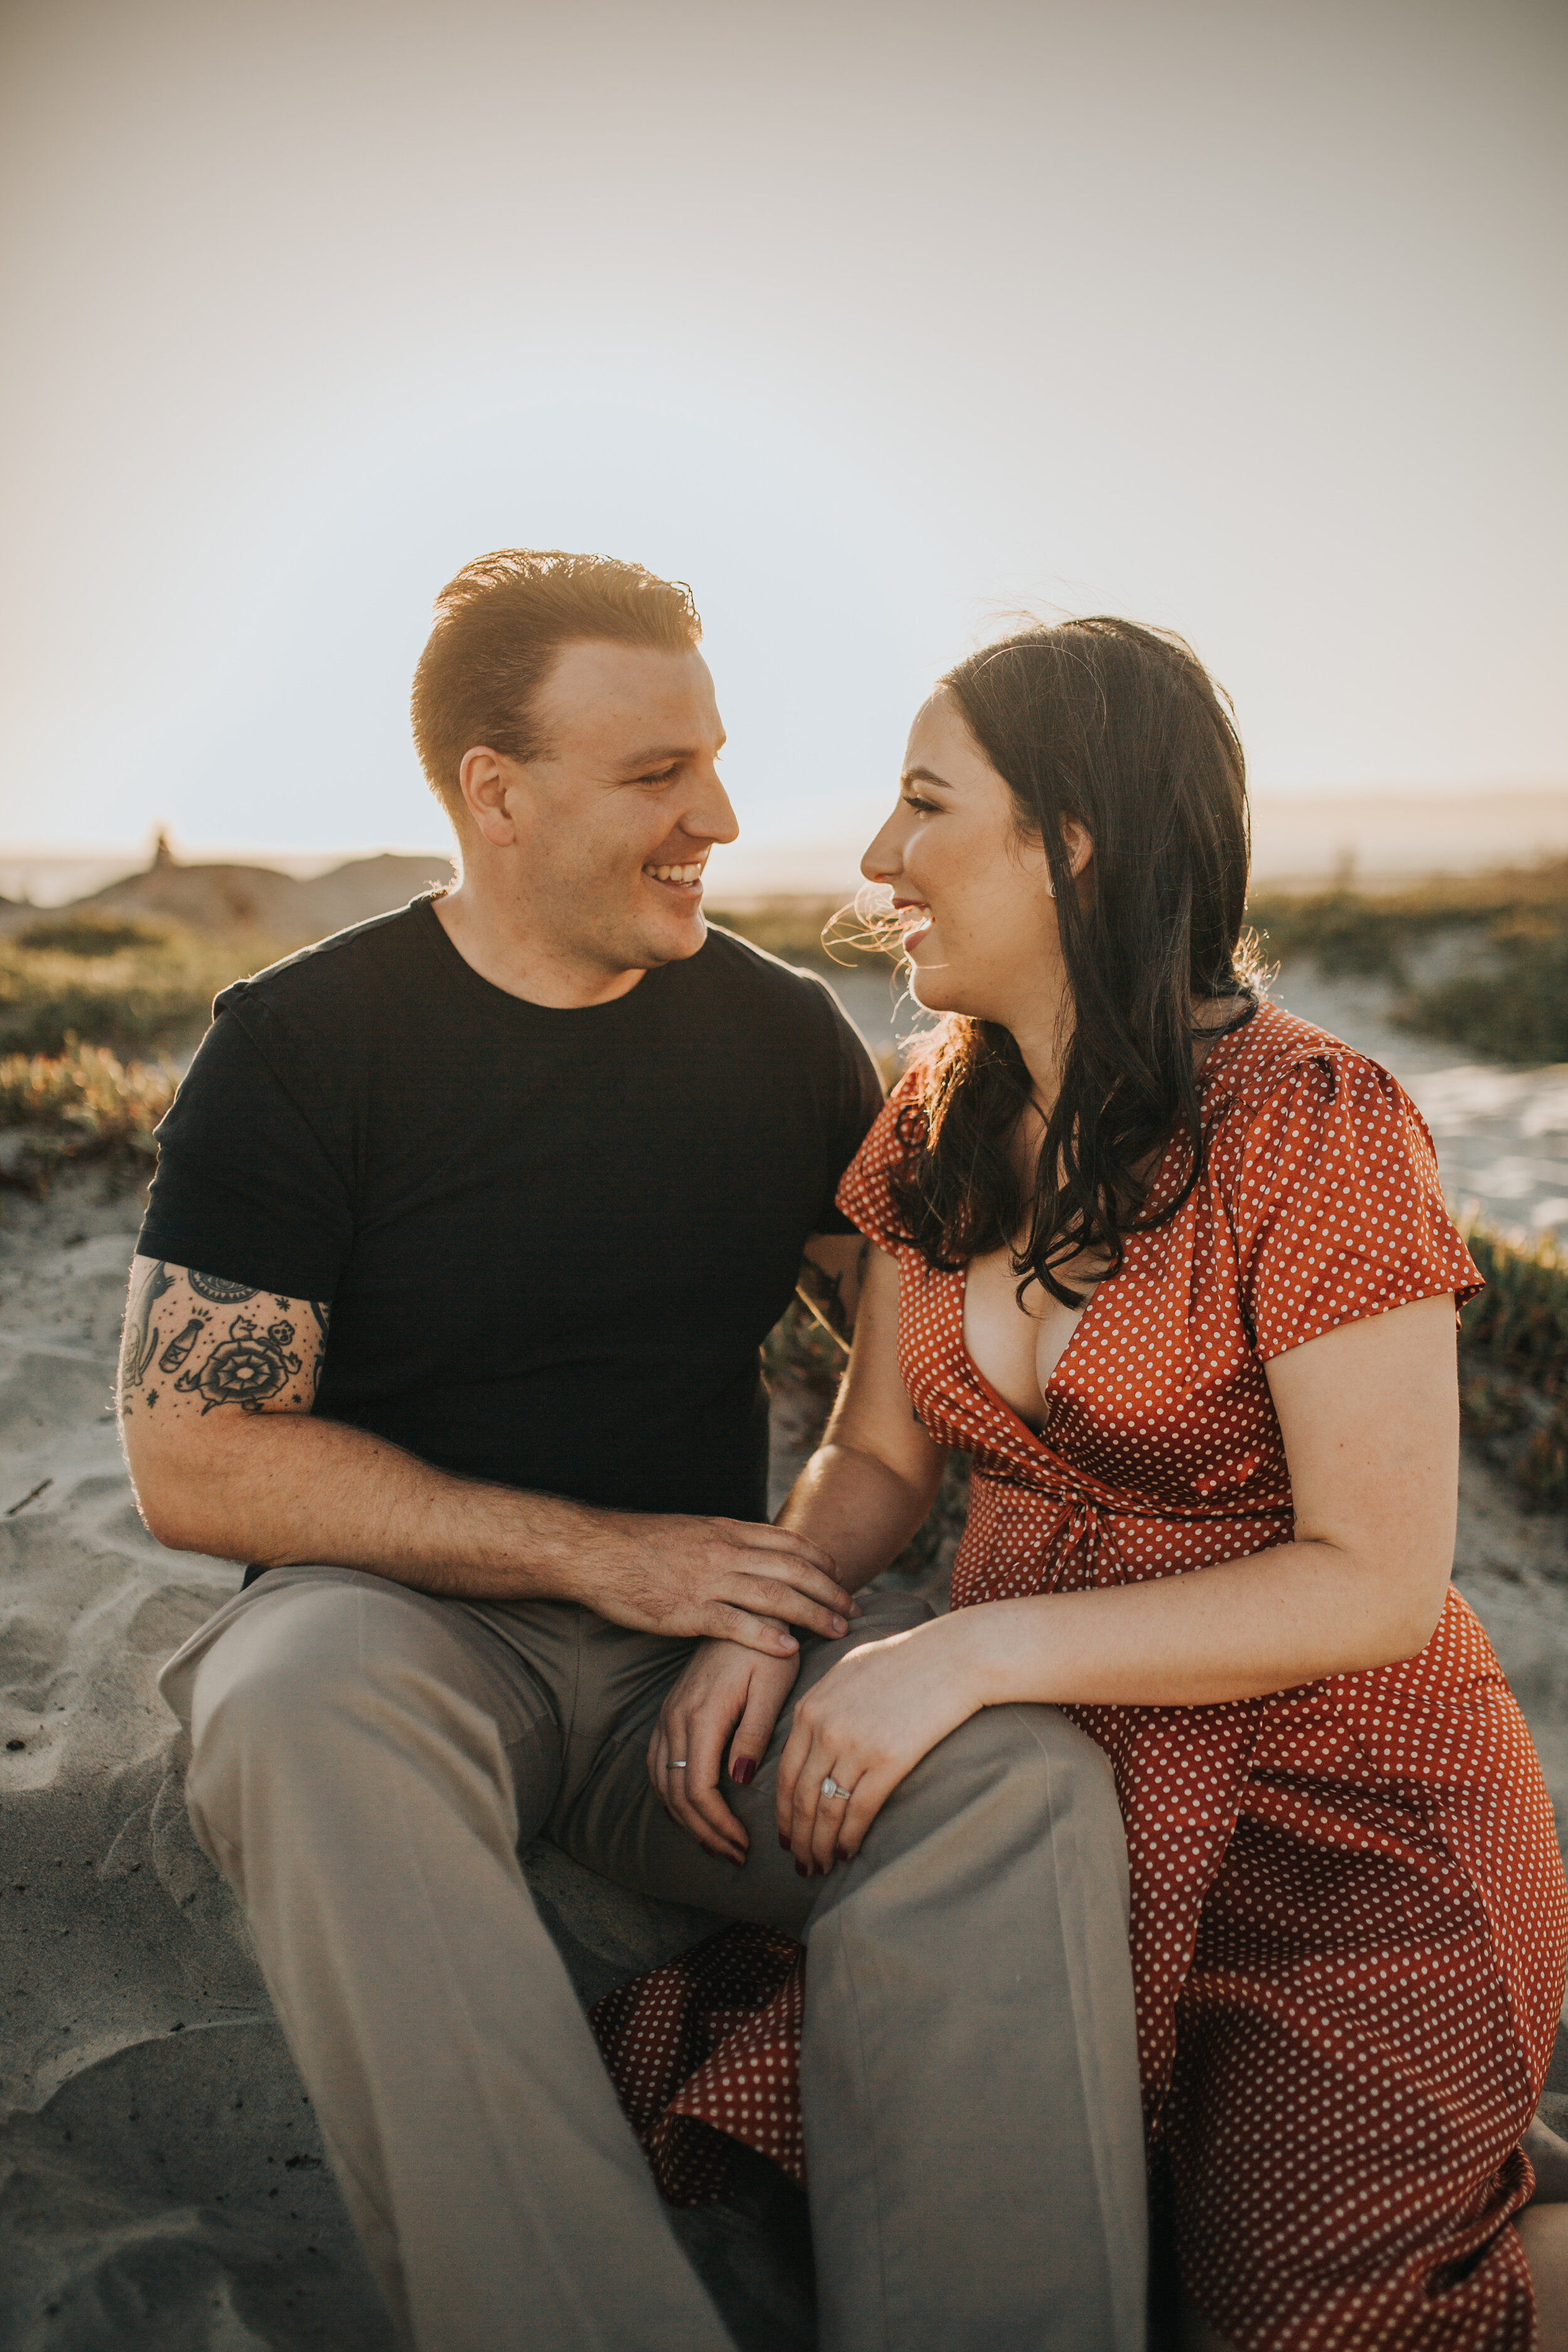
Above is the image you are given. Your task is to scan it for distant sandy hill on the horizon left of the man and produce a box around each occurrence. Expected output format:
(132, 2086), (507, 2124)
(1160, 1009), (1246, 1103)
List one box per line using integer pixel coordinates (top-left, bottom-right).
(0, 852), (452, 948)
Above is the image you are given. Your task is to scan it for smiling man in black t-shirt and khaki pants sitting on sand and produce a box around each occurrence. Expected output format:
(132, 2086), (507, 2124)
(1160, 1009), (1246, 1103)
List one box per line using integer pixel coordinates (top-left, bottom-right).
(122, 553), (1138, 2352)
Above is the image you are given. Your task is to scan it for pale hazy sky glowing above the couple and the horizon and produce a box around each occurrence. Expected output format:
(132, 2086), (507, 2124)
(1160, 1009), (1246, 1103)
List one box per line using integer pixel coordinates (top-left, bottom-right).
(0, 0), (1568, 879)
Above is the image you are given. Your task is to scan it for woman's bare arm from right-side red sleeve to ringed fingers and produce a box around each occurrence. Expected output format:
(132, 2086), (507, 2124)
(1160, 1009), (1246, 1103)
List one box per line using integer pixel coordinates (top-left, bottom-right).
(778, 1294), (1460, 1870)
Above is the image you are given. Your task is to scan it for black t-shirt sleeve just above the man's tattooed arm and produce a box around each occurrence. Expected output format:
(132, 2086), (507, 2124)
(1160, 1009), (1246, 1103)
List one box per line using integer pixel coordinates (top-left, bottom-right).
(136, 1000), (352, 1301)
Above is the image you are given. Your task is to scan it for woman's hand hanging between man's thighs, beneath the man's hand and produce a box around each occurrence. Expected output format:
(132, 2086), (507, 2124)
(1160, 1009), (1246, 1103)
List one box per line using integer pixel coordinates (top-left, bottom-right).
(649, 1642), (799, 1863)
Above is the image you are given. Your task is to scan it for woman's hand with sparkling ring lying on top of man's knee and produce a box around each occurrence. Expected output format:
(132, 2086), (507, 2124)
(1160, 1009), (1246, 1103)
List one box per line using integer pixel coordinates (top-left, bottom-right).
(778, 1609), (985, 1877)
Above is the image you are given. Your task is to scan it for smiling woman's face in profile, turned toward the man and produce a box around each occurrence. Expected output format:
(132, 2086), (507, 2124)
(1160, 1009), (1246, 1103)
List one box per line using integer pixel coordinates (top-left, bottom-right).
(861, 687), (1088, 1030)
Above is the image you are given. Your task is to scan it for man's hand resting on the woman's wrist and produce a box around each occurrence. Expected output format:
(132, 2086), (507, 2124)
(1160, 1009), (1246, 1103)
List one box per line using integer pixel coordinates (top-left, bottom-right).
(562, 1510), (861, 1677)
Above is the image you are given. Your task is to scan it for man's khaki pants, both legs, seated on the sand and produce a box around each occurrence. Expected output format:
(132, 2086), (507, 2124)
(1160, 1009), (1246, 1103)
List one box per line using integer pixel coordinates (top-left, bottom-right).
(162, 1567), (1145, 2352)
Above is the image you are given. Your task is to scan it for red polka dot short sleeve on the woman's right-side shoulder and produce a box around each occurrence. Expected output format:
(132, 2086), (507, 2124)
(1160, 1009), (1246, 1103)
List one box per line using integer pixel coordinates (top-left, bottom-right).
(1234, 1049), (1481, 1362)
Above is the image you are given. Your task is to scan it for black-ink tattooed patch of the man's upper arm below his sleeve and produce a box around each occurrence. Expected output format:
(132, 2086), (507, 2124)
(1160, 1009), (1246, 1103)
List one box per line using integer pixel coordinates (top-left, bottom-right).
(120, 1258), (329, 1421)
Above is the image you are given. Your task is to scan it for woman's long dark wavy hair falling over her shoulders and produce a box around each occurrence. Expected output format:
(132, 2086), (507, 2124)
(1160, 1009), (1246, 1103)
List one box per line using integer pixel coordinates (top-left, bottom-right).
(893, 618), (1258, 1308)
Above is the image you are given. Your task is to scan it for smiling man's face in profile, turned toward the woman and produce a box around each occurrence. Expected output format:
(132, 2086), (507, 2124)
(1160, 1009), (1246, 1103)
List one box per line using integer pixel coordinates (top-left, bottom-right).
(491, 642), (738, 976)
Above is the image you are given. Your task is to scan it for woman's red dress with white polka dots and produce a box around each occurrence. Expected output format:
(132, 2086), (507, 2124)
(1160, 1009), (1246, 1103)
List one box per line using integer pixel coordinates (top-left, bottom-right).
(601, 1004), (1568, 2352)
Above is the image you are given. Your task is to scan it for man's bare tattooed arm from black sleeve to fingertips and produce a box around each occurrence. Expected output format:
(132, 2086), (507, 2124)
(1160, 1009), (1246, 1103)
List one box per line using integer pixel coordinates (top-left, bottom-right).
(120, 1256), (851, 1656)
